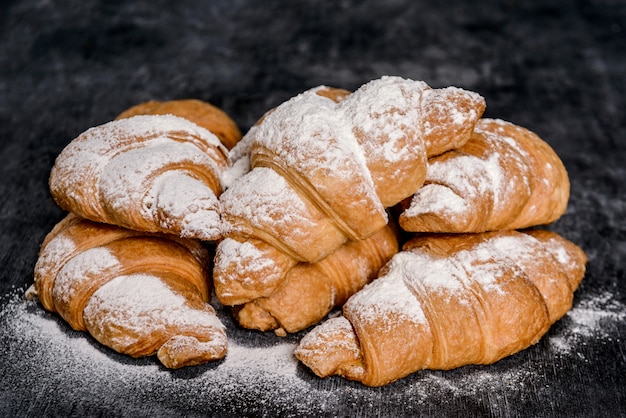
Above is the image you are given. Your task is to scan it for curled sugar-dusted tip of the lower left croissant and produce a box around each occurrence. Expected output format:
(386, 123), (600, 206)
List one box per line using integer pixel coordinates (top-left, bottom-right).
(157, 335), (227, 369)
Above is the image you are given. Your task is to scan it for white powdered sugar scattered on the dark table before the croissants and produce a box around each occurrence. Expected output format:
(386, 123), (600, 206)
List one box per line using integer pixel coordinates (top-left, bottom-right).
(0, 284), (626, 416)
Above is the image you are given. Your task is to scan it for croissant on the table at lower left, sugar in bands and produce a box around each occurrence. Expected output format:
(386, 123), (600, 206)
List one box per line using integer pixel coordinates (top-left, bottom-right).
(33, 214), (227, 368)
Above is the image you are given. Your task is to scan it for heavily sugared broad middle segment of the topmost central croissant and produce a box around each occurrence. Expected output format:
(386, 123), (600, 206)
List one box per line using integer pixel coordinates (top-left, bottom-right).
(250, 85), (384, 229)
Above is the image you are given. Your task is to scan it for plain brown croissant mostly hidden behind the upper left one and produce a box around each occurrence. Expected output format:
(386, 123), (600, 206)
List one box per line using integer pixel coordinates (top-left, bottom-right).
(117, 99), (241, 149)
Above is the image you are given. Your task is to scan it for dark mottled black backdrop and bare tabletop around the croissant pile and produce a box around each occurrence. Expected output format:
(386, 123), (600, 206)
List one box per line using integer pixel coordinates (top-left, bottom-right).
(0, 0), (626, 416)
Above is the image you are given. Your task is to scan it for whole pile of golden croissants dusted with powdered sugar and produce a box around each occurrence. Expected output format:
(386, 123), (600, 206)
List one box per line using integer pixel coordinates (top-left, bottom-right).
(31, 76), (587, 386)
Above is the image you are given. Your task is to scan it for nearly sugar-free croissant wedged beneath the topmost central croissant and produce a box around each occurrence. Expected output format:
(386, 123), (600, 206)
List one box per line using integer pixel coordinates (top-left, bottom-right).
(235, 226), (398, 336)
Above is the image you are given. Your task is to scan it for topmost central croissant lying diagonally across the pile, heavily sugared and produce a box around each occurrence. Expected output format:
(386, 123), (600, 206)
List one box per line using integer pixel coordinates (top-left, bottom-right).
(214, 77), (485, 305)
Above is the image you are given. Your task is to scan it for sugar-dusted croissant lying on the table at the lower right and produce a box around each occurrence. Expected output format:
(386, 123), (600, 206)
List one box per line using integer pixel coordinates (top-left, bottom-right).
(295, 231), (586, 386)
